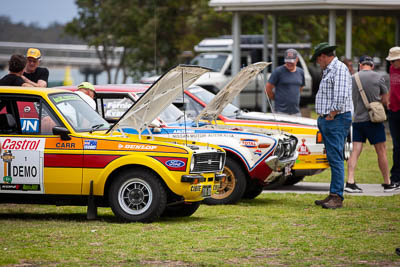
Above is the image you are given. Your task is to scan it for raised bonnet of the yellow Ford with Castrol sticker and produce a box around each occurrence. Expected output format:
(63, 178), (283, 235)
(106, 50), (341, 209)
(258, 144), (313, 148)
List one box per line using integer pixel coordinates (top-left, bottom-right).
(109, 65), (210, 133)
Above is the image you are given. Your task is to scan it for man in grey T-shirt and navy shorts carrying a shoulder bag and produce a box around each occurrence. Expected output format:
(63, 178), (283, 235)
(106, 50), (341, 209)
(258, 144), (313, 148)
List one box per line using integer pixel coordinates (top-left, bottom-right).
(344, 56), (399, 193)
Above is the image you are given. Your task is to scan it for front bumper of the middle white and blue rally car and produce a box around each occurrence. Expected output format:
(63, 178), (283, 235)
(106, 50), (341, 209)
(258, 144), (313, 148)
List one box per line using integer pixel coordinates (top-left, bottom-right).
(264, 151), (298, 183)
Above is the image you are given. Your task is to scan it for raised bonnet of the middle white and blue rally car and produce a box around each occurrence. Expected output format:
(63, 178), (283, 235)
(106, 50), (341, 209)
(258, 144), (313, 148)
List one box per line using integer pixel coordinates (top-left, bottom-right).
(195, 62), (271, 121)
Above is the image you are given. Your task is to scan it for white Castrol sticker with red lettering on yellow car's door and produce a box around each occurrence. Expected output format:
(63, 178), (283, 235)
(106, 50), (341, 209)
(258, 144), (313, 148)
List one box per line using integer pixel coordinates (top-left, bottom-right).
(0, 137), (46, 151)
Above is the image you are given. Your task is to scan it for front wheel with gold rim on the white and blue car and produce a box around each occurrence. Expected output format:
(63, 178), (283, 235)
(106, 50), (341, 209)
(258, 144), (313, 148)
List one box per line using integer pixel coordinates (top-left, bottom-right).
(203, 157), (246, 205)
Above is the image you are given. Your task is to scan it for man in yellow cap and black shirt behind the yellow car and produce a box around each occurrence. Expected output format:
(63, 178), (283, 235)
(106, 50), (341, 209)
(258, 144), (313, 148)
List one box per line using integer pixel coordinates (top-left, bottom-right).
(22, 48), (49, 87)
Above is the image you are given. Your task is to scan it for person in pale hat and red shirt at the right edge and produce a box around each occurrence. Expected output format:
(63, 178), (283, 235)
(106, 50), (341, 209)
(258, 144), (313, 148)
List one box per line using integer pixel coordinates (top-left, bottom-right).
(386, 46), (400, 188)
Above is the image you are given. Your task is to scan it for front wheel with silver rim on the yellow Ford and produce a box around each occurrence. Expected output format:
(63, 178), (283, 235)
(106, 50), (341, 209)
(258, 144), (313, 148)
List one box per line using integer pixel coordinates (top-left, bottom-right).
(108, 169), (167, 222)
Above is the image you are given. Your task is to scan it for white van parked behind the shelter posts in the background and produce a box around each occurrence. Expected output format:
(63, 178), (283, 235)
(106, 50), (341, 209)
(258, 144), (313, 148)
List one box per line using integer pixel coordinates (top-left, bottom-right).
(190, 35), (312, 111)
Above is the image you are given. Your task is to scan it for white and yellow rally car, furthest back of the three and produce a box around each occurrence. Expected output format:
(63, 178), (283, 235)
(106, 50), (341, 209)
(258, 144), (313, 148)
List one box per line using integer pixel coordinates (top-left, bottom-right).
(141, 63), (332, 189)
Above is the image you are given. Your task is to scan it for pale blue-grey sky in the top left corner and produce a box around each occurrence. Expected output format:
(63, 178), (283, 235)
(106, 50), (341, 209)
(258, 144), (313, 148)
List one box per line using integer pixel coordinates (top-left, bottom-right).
(0, 0), (78, 28)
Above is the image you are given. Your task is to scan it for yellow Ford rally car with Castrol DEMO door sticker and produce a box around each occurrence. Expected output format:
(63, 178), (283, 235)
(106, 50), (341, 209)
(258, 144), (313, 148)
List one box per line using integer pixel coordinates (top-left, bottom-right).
(0, 66), (225, 222)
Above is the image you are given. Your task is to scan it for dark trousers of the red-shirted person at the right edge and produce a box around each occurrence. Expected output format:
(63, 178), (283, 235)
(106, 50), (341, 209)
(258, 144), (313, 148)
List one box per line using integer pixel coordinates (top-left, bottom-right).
(388, 110), (400, 183)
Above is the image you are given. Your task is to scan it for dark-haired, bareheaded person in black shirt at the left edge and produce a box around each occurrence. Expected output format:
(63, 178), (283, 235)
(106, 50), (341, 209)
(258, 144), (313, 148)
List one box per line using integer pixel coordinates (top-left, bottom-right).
(0, 54), (30, 86)
